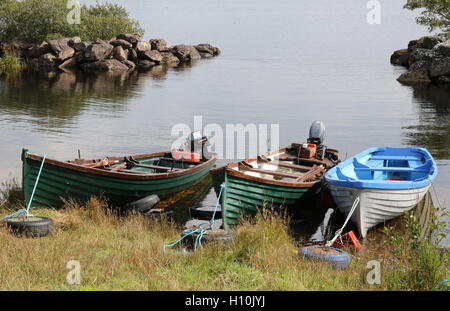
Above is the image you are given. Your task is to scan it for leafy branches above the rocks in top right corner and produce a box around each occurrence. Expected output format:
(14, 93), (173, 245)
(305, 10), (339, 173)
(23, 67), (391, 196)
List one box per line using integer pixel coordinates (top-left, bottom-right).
(405, 0), (450, 33)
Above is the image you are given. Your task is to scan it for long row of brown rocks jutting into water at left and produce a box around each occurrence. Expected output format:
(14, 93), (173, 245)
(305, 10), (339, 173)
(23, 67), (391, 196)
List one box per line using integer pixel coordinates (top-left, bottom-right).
(0, 34), (220, 72)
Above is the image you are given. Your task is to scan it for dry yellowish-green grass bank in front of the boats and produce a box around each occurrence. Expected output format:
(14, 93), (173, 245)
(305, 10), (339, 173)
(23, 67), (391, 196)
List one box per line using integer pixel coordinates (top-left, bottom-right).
(0, 184), (449, 291)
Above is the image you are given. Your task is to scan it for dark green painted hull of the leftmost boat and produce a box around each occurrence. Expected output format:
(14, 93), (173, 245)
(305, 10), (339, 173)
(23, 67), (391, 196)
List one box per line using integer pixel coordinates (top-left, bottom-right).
(22, 152), (215, 208)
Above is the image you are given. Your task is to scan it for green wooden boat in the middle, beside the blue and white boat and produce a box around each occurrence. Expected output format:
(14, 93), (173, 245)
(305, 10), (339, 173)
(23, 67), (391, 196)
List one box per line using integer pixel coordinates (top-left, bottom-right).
(216, 144), (339, 229)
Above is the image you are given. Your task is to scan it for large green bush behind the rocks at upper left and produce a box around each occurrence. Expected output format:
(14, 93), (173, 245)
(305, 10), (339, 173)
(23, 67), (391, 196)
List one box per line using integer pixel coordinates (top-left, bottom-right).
(0, 0), (144, 41)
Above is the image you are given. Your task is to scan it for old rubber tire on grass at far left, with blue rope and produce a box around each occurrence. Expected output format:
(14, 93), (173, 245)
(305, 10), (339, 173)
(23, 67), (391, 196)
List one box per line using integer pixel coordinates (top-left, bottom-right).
(6, 216), (55, 238)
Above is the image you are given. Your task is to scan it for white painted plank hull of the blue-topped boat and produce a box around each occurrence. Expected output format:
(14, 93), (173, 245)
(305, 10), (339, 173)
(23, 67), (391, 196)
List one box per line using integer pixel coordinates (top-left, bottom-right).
(328, 184), (430, 238)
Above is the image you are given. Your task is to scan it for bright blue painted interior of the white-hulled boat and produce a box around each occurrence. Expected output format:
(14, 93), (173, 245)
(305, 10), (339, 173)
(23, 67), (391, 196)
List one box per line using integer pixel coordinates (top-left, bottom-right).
(336, 148), (434, 182)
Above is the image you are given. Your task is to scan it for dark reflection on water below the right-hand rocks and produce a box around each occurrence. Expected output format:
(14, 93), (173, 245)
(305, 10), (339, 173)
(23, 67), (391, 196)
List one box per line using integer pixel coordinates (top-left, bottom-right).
(403, 85), (450, 159)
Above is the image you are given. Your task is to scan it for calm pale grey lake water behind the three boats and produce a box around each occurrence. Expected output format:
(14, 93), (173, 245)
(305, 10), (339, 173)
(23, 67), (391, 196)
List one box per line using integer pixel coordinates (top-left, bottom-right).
(0, 0), (450, 247)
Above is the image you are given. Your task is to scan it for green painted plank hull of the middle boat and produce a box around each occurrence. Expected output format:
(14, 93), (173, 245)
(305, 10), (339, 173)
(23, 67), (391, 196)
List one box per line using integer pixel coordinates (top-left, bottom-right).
(222, 173), (320, 229)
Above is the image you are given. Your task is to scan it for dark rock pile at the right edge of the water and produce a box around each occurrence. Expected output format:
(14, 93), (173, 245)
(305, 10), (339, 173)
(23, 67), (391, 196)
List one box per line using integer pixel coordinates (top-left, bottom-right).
(391, 36), (450, 85)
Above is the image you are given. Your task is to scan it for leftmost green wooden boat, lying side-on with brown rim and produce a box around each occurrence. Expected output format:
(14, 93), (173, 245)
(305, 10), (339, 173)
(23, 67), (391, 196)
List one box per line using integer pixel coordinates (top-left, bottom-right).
(22, 149), (216, 207)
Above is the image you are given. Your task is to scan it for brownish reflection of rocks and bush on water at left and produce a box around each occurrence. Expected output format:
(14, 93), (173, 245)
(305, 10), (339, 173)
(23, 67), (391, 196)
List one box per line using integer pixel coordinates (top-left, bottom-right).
(0, 64), (191, 132)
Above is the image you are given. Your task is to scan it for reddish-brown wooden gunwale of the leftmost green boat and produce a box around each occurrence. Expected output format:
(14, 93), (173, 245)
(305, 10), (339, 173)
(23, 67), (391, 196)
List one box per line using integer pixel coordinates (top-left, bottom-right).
(23, 151), (217, 180)
